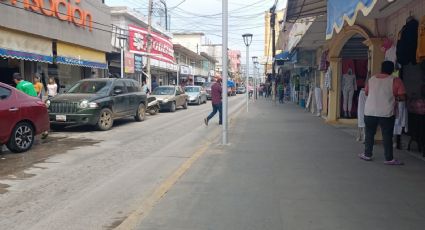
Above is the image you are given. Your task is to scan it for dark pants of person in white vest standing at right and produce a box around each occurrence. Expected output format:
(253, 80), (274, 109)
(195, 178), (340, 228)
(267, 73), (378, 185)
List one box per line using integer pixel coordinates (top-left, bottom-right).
(364, 116), (395, 161)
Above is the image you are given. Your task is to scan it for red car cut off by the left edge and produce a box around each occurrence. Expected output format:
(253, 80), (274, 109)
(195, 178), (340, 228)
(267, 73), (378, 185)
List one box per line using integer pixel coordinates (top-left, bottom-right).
(0, 83), (50, 153)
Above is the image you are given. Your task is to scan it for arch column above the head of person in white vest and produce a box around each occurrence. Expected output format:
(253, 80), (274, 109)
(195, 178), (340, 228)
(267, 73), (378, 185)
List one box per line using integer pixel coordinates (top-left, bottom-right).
(363, 38), (385, 76)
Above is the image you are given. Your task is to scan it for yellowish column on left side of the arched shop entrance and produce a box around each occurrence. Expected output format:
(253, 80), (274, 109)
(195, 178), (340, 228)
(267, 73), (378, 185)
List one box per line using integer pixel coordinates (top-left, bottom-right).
(326, 57), (342, 123)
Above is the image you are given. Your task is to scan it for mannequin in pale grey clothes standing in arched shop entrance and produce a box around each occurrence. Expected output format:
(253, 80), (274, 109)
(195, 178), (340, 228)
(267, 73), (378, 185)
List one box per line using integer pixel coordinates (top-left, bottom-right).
(342, 68), (357, 117)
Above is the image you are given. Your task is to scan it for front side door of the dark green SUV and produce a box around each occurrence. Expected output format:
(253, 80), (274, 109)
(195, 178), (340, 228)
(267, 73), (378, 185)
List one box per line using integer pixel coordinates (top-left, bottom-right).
(112, 79), (129, 116)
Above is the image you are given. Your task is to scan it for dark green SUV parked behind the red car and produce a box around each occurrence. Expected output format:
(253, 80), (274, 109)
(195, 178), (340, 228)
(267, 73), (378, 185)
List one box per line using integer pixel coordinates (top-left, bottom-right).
(46, 78), (146, 131)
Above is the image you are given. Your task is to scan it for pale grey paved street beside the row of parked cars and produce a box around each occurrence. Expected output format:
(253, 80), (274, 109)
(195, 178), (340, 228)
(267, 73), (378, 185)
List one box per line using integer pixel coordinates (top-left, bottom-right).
(0, 96), (243, 230)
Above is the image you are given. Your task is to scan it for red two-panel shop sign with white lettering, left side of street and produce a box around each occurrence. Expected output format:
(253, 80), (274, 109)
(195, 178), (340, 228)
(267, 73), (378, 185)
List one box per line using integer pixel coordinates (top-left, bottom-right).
(128, 26), (175, 64)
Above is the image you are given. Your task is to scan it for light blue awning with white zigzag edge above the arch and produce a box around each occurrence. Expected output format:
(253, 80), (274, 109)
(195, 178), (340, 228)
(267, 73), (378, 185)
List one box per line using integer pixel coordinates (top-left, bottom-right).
(326, 0), (378, 39)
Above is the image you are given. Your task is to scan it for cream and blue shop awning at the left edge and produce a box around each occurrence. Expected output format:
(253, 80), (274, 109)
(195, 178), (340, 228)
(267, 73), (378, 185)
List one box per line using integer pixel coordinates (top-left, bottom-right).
(0, 28), (53, 63)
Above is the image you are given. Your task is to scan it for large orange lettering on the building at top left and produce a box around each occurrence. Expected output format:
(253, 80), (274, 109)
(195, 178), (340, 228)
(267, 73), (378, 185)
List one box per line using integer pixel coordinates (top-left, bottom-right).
(0, 0), (93, 31)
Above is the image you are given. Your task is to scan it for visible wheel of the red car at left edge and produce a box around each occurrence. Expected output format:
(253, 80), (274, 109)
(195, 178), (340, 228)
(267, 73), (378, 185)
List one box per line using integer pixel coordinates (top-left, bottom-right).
(6, 122), (34, 153)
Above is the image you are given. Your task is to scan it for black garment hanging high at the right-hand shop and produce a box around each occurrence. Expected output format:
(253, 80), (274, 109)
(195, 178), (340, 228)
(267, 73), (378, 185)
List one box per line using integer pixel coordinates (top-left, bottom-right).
(396, 18), (419, 65)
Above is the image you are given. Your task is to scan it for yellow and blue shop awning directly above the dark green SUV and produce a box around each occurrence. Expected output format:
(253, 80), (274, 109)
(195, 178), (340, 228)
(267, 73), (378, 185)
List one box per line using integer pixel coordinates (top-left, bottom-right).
(56, 42), (108, 69)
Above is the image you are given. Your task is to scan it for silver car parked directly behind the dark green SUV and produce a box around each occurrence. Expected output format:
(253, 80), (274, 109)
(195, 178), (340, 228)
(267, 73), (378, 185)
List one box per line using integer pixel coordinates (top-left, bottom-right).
(152, 85), (189, 112)
